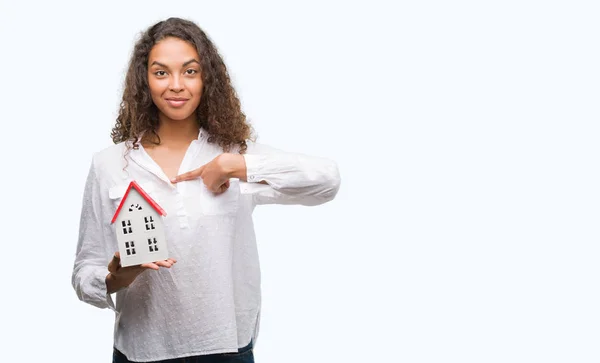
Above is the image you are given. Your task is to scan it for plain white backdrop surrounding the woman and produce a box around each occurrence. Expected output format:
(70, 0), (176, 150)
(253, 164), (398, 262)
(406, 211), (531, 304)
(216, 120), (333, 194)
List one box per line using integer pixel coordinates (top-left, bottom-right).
(0, 0), (600, 363)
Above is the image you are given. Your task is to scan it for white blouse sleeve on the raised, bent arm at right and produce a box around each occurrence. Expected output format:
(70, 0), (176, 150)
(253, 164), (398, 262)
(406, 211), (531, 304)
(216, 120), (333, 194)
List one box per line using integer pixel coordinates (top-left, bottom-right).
(242, 141), (340, 206)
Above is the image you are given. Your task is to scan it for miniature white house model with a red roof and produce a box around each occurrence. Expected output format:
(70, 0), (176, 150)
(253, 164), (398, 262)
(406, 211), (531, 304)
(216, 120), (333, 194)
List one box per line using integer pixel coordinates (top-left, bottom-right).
(111, 181), (169, 267)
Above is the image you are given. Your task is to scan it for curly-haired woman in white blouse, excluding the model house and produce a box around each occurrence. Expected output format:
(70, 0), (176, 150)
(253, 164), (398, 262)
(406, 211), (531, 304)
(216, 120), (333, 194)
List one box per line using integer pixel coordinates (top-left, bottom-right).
(72, 18), (340, 362)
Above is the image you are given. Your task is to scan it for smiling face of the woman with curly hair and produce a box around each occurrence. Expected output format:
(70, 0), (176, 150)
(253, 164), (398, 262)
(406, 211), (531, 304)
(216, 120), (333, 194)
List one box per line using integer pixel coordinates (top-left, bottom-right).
(148, 37), (202, 121)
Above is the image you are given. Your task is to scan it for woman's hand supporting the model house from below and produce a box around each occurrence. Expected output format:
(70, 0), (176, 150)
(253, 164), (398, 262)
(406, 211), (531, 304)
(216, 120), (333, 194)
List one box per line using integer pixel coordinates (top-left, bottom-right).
(106, 252), (177, 294)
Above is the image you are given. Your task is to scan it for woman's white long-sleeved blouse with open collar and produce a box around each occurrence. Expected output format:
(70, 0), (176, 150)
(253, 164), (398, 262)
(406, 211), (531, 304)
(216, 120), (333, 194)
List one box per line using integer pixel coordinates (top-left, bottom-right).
(72, 129), (340, 362)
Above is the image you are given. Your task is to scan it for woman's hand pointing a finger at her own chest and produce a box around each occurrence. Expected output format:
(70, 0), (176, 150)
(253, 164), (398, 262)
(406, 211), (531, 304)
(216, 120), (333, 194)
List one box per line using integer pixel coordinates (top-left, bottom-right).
(171, 153), (245, 194)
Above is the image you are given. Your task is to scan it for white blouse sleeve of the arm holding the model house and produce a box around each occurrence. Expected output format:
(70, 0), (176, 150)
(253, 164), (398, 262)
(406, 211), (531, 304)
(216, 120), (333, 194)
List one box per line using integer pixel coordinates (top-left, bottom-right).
(71, 155), (116, 311)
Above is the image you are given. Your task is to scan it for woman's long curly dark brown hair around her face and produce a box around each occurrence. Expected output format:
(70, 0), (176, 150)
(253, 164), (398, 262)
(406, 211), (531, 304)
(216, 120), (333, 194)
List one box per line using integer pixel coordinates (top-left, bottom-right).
(111, 17), (253, 154)
